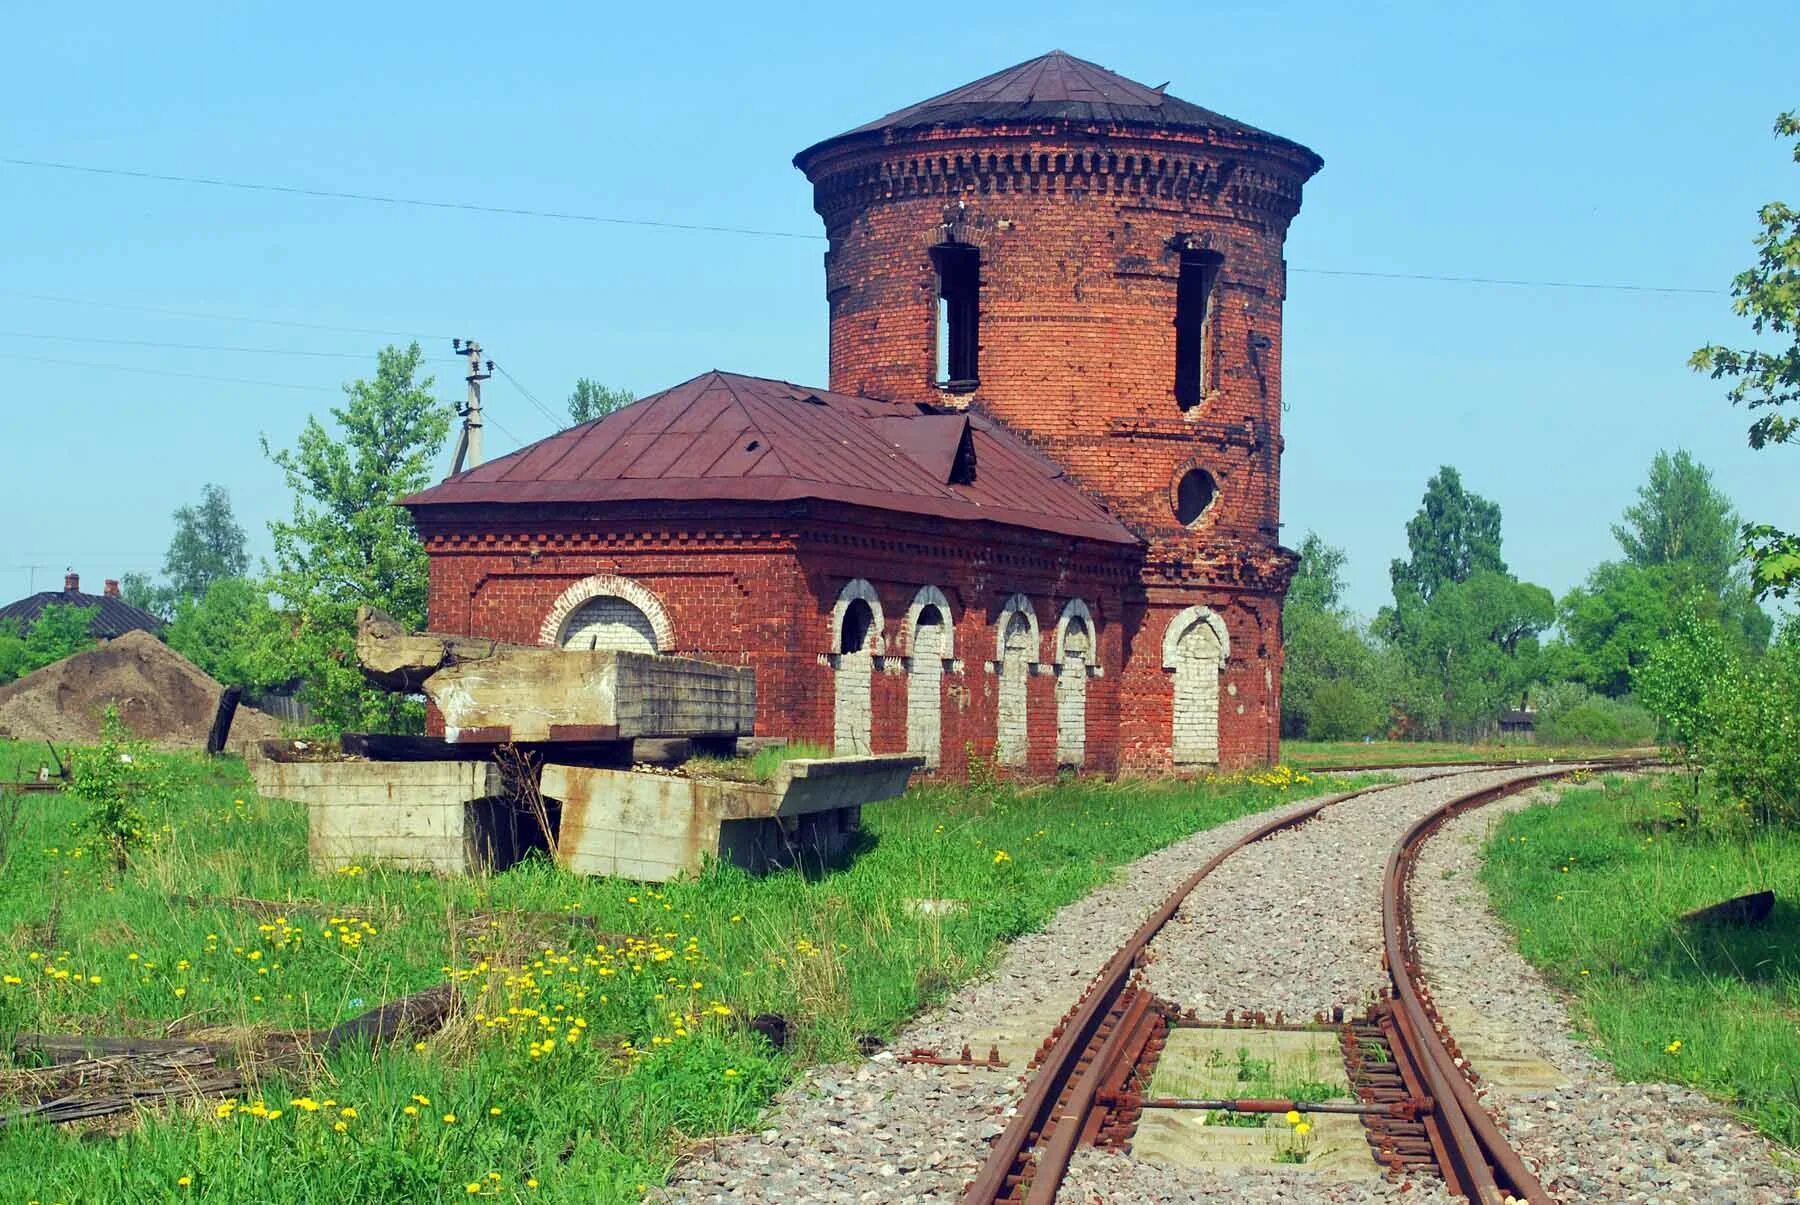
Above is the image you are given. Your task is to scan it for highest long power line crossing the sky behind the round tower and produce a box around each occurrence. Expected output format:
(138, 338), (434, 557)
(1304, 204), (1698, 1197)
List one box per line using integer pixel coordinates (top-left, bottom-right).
(0, 157), (1726, 295)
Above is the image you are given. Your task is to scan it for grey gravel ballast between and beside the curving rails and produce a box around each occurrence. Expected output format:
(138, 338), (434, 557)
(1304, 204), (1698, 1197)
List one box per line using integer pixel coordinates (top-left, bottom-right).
(657, 769), (1795, 1205)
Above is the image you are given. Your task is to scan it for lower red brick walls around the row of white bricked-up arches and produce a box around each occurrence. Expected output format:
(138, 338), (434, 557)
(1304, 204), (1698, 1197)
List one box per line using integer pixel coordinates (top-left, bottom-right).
(421, 504), (1280, 778)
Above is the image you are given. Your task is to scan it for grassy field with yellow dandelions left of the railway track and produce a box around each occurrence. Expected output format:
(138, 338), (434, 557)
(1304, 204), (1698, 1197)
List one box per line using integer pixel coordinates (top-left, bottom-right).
(0, 744), (1353, 1205)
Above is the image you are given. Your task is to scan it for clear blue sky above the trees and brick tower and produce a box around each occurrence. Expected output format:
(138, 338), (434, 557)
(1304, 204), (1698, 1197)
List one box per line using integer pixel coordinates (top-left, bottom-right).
(0, 2), (1800, 611)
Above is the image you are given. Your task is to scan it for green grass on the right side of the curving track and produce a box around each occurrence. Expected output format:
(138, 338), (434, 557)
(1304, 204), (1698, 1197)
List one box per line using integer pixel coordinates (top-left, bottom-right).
(1483, 778), (1800, 1146)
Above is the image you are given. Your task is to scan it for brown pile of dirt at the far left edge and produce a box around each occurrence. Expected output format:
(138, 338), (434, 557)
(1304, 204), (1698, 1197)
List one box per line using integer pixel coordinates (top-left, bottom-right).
(0, 632), (281, 749)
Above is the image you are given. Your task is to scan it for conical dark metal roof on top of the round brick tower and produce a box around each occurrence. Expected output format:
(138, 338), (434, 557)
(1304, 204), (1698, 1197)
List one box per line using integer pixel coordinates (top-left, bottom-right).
(794, 50), (1318, 171)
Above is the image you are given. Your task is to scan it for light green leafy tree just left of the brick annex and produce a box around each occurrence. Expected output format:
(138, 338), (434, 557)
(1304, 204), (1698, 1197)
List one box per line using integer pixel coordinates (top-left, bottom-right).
(263, 344), (450, 728)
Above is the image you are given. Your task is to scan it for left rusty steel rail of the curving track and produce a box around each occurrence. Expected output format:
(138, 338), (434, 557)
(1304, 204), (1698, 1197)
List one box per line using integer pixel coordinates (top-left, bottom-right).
(961, 771), (1476, 1205)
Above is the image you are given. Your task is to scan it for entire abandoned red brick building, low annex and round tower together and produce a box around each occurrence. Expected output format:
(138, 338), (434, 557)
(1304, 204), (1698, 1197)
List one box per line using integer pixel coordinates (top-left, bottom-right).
(405, 52), (1321, 776)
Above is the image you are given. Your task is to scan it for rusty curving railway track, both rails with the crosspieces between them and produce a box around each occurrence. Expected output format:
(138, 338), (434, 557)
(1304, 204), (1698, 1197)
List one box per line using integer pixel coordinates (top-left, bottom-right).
(961, 760), (1645, 1205)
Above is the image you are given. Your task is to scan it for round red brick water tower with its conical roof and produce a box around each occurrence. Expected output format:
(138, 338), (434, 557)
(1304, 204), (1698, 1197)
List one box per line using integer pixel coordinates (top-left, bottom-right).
(794, 50), (1323, 769)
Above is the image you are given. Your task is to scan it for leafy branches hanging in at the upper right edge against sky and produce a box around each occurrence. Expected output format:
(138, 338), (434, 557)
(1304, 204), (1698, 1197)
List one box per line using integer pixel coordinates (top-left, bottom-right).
(1688, 112), (1800, 598)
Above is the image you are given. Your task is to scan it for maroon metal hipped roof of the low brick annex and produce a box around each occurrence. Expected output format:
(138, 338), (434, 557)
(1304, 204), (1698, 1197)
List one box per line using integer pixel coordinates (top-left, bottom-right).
(400, 371), (1138, 544)
